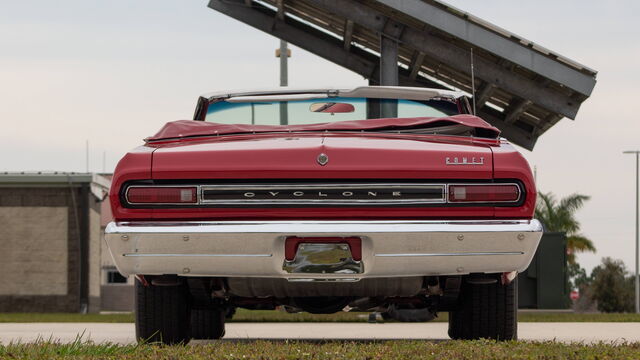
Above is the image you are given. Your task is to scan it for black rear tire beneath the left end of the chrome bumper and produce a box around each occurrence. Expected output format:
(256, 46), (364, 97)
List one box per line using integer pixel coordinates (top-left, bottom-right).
(135, 279), (189, 345)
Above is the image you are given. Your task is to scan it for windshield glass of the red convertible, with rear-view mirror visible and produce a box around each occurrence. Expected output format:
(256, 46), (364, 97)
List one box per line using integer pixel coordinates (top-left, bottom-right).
(205, 97), (460, 125)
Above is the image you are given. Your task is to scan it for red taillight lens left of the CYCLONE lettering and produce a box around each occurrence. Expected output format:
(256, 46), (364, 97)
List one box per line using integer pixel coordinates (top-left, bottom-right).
(127, 186), (198, 204)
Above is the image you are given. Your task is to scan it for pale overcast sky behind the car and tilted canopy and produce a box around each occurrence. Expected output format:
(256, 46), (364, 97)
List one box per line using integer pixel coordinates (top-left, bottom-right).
(0, 0), (640, 269)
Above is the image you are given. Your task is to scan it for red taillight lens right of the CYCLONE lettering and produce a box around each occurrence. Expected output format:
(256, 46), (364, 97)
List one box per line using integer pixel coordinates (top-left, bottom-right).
(449, 184), (520, 203)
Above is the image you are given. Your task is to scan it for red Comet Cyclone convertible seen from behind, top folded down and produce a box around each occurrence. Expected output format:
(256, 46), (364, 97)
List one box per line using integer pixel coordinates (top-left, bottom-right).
(106, 86), (542, 343)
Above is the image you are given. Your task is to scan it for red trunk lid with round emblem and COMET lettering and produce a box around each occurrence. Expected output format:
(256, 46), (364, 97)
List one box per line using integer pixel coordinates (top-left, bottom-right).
(152, 134), (493, 180)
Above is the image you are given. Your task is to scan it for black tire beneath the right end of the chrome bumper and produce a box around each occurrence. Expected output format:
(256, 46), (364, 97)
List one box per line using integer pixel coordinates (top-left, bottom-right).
(449, 279), (518, 340)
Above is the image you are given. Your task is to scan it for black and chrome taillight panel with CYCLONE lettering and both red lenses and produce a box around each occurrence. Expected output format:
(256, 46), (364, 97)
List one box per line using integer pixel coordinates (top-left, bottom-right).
(121, 181), (525, 208)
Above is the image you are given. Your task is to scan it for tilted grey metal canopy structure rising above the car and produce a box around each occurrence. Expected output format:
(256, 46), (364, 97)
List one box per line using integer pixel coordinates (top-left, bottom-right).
(209, 0), (596, 150)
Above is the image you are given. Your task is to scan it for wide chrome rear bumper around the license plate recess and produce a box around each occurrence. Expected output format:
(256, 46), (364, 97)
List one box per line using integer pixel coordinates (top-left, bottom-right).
(105, 220), (542, 281)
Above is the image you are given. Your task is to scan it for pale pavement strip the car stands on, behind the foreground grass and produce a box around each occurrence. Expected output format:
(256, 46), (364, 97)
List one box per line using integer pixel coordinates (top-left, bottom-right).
(0, 322), (640, 344)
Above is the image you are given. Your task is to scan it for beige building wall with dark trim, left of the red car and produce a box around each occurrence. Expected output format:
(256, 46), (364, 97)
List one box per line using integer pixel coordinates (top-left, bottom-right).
(0, 183), (100, 312)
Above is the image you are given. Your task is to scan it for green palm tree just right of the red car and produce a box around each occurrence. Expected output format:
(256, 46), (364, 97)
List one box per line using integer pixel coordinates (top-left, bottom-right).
(536, 193), (596, 264)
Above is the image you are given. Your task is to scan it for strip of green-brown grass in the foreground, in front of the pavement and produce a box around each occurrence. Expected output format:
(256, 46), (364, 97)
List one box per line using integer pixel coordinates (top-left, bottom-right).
(0, 339), (640, 360)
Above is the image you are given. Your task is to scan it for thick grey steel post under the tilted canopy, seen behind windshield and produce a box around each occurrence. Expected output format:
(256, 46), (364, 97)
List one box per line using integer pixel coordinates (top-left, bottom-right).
(380, 35), (399, 118)
